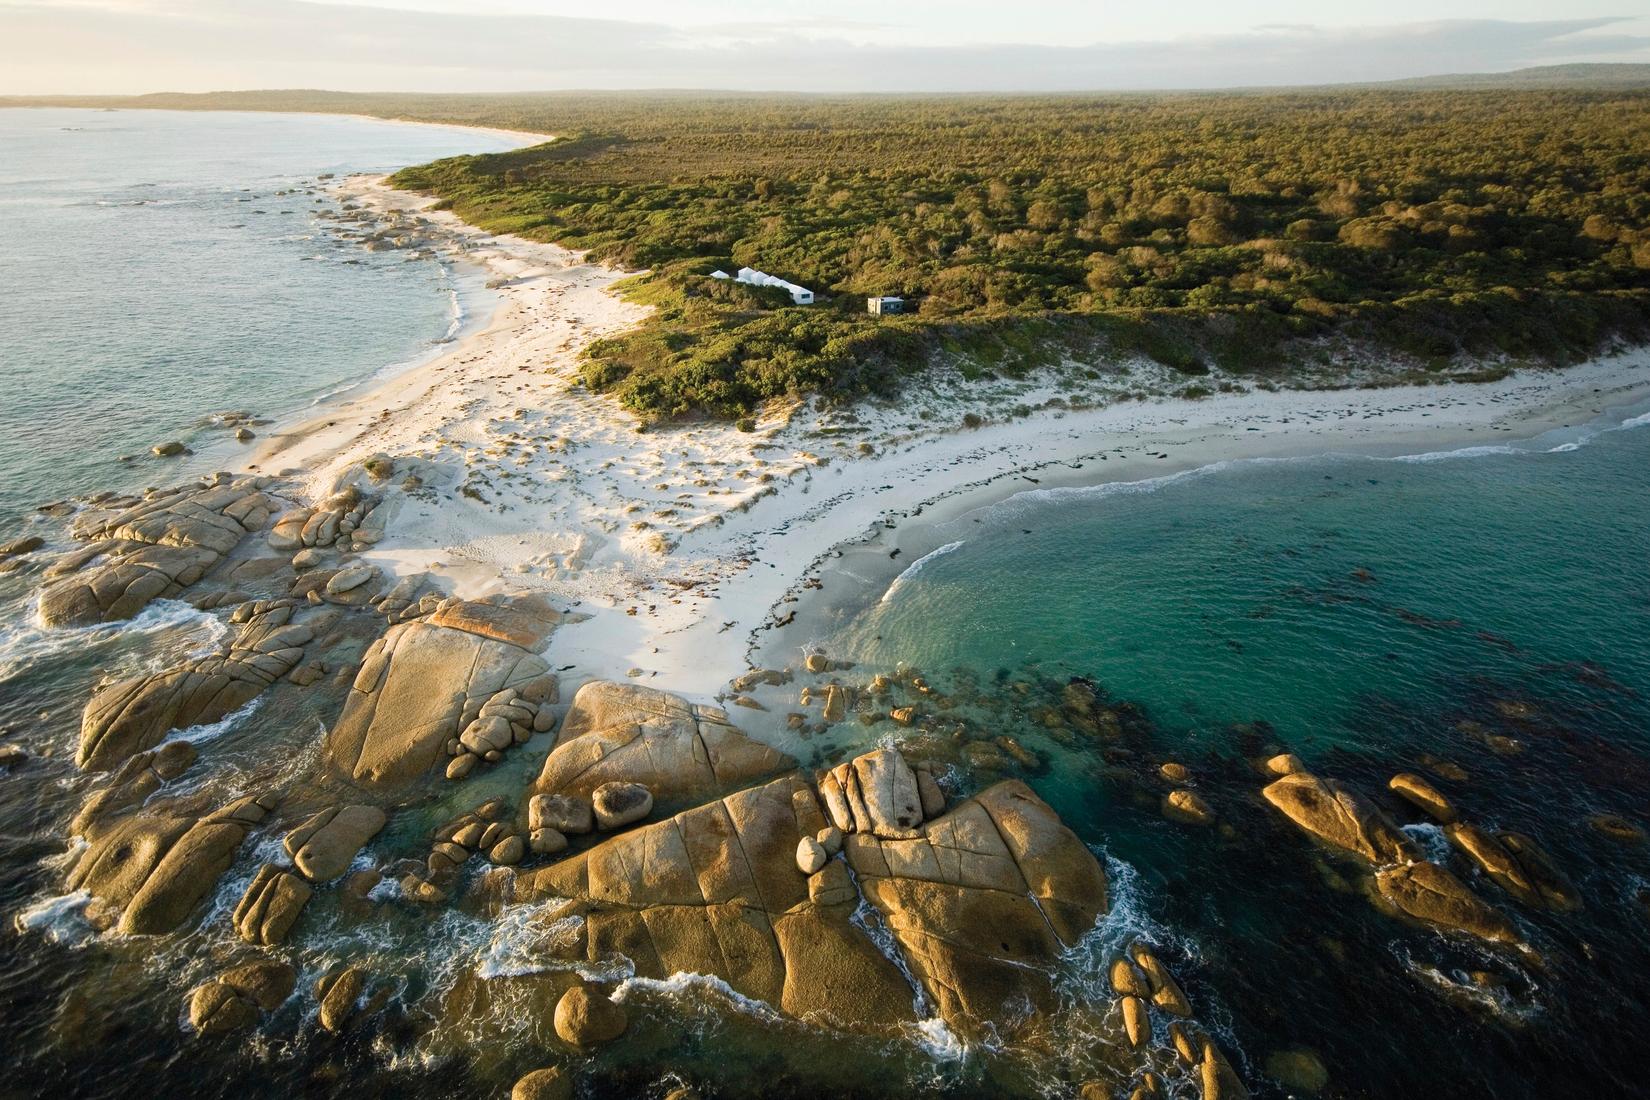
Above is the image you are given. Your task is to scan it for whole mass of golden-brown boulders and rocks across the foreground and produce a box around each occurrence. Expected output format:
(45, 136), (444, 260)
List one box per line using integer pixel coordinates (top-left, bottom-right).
(0, 477), (1635, 1100)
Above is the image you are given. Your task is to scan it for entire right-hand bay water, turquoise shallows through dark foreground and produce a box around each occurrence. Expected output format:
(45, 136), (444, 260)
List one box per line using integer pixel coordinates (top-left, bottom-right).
(805, 407), (1650, 1097)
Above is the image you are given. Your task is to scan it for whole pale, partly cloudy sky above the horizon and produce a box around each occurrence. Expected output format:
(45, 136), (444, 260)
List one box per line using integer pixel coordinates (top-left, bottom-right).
(0, 0), (1650, 94)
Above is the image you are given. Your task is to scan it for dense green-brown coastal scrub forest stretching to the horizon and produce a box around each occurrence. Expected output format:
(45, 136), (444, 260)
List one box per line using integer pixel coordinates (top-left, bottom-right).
(12, 89), (1650, 416)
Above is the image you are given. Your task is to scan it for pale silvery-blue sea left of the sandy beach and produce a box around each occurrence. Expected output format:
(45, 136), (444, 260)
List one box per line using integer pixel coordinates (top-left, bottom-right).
(0, 109), (513, 534)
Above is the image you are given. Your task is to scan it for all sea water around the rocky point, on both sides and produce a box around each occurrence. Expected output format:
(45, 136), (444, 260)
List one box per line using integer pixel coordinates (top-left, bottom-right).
(0, 112), (1650, 1100)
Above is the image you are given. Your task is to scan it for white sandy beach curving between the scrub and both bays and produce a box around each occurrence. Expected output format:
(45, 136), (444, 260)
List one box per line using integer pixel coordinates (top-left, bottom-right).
(244, 176), (1650, 699)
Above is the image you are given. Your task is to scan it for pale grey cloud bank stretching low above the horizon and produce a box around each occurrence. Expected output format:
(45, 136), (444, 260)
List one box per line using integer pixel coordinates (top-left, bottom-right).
(0, 0), (1650, 92)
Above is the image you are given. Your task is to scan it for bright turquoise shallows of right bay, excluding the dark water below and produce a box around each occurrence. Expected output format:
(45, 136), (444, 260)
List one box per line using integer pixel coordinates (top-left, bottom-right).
(828, 408), (1650, 760)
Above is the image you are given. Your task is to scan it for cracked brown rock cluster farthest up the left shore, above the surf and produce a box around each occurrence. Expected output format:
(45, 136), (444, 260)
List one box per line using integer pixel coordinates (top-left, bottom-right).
(40, 475), (276, 627)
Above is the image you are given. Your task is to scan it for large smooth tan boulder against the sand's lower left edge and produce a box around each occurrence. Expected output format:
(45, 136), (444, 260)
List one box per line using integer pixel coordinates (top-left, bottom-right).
(327, 602), (556, 787)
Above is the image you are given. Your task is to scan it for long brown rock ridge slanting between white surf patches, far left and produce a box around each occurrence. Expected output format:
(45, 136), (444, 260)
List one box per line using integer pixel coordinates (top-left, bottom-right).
(74, 600), (315, 770)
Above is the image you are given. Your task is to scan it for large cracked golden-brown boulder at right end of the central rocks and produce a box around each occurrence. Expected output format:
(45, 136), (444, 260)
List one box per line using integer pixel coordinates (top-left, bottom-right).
(843, 780), (1107, 1039)
